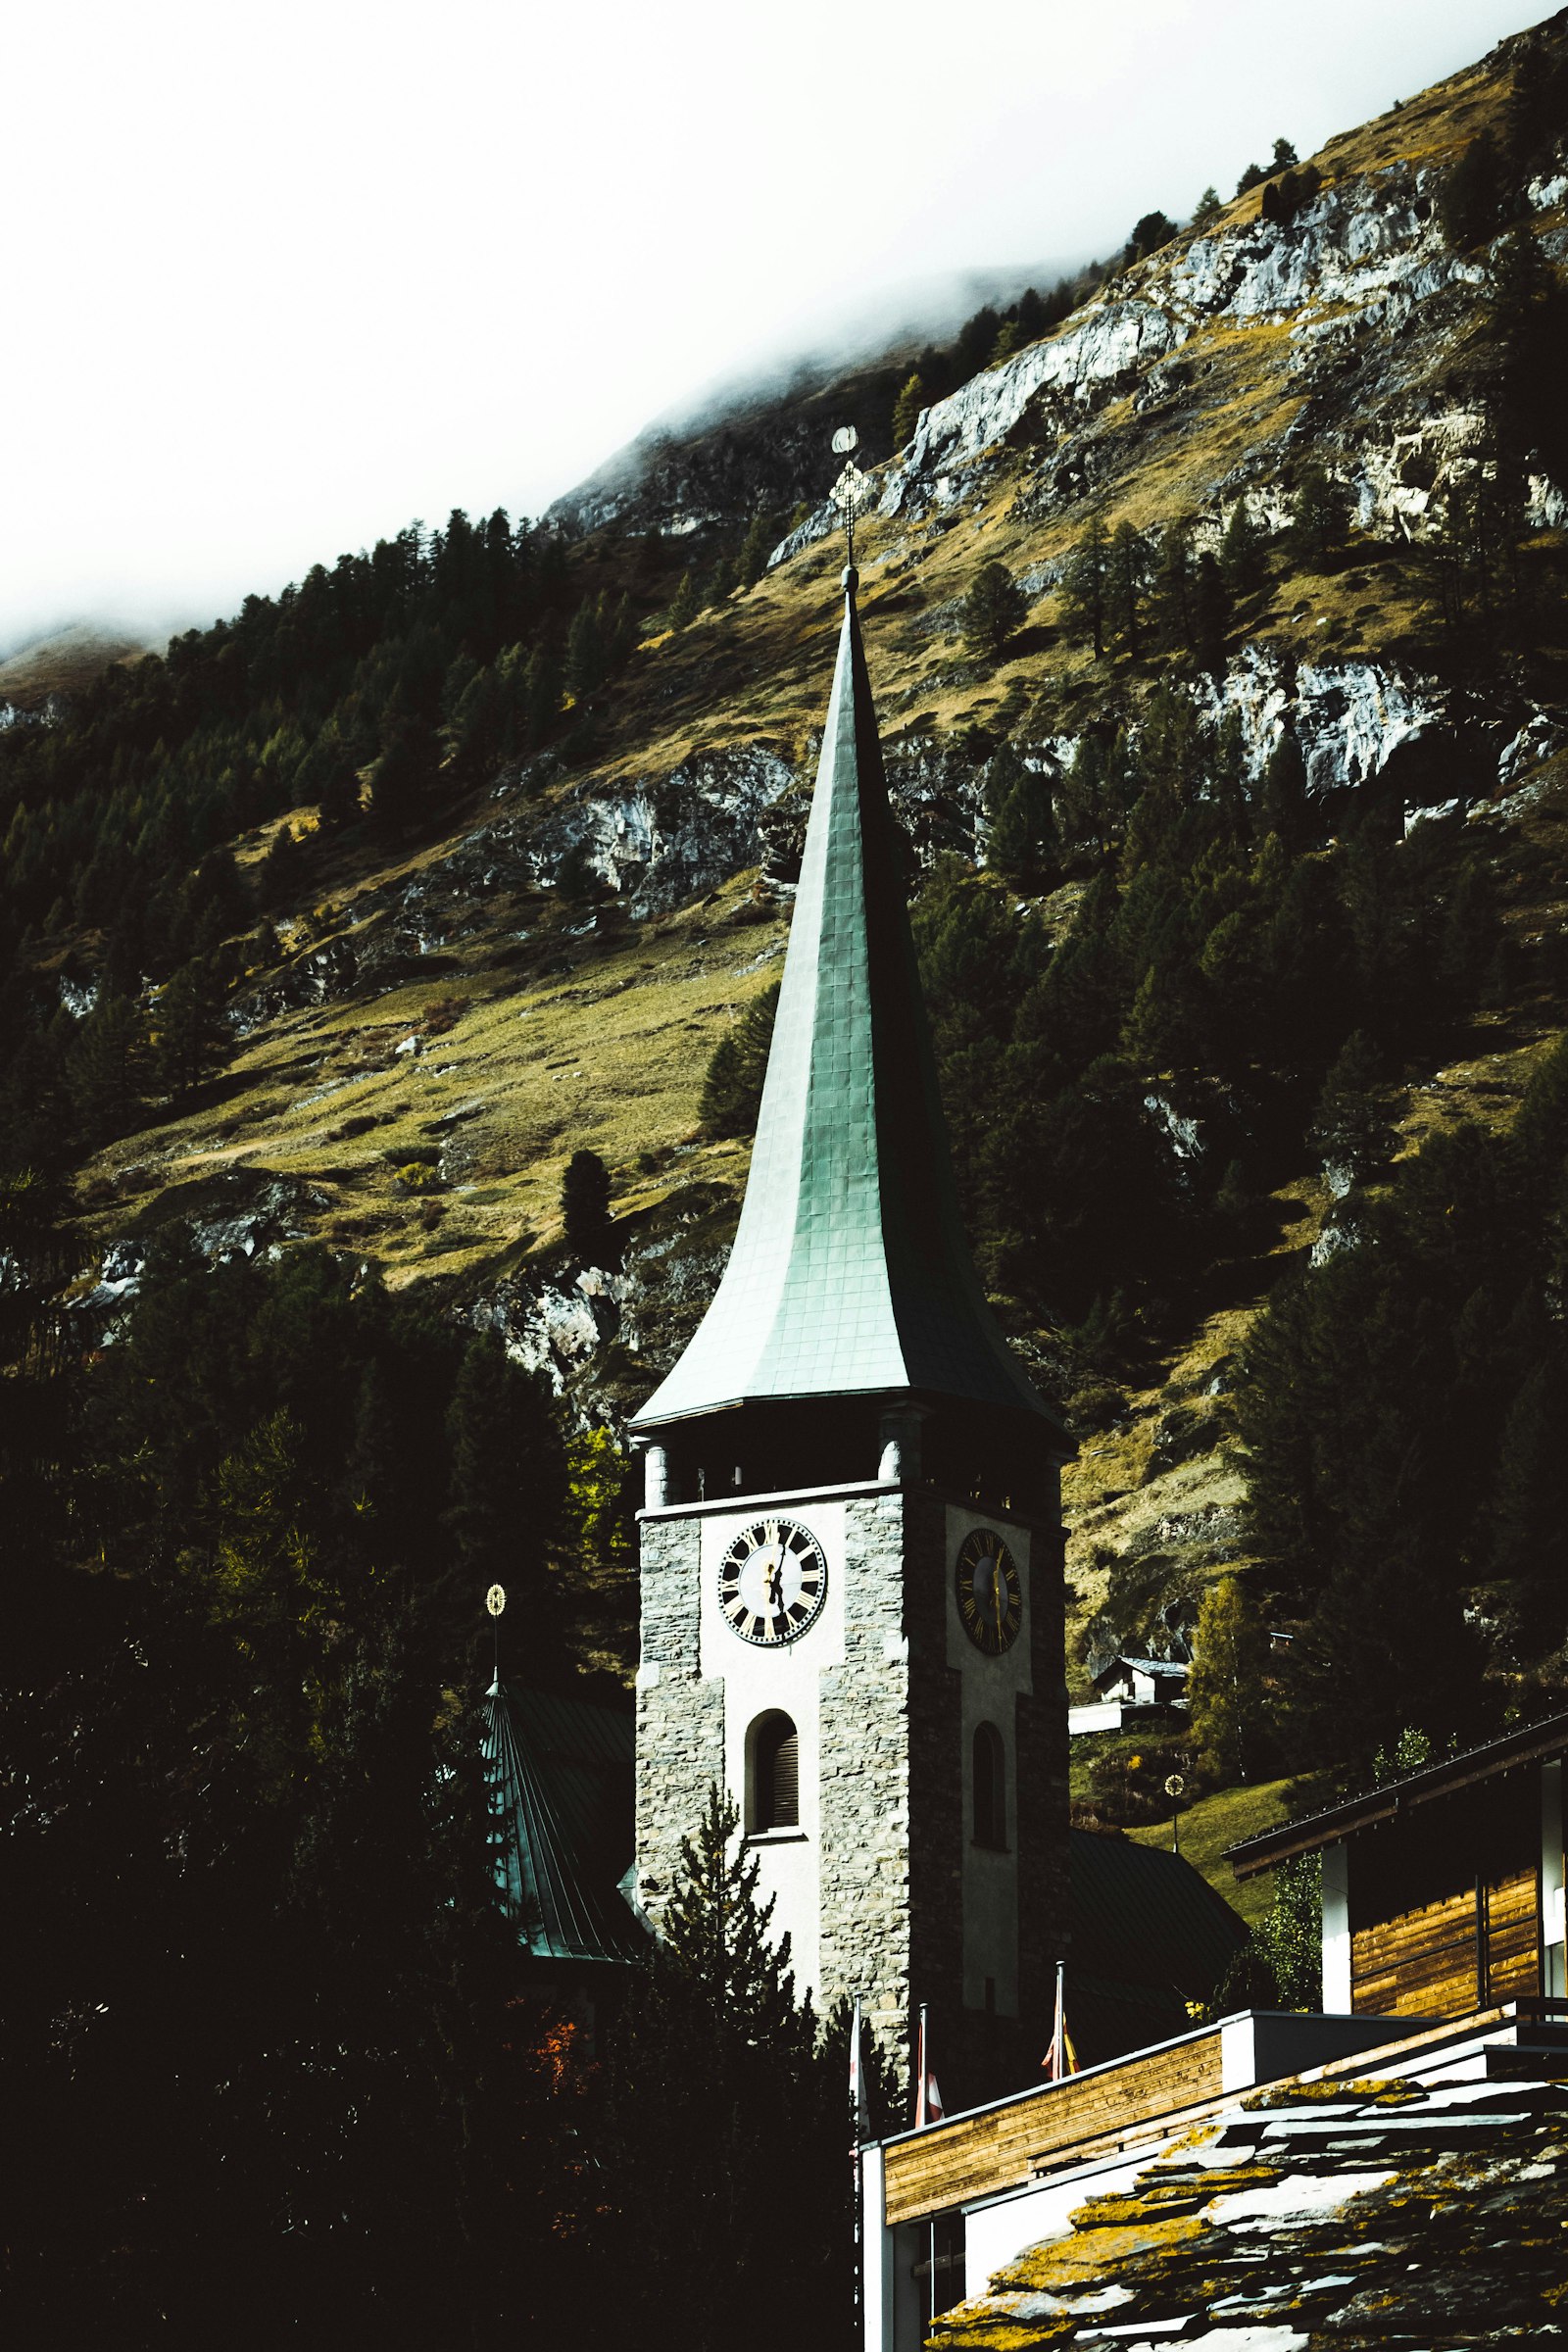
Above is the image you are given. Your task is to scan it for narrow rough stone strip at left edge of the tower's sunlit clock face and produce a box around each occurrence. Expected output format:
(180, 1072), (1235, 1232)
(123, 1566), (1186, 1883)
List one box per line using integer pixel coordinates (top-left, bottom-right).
(637, 1519), (724, 1919)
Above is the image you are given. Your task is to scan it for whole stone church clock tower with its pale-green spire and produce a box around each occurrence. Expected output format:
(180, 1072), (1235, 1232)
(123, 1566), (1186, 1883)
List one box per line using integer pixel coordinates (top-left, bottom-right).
(632, 569), (1069, 2110)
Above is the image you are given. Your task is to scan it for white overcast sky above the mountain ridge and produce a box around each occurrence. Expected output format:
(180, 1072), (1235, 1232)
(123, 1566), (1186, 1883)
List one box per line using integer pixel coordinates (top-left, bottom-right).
(0, 0), (1540, 649)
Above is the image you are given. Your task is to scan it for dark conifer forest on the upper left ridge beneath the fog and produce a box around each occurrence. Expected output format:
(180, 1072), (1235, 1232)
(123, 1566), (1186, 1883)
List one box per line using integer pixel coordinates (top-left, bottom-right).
(0, 511), (686, 1185)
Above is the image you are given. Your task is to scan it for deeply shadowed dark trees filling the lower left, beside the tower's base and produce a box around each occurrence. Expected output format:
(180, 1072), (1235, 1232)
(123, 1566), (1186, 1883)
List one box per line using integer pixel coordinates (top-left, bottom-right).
(0, 1223), (896, 2352)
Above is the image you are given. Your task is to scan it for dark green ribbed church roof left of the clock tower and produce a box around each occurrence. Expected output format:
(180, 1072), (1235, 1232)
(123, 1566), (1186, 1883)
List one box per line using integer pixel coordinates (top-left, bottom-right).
(484, 1682), (647, 1962)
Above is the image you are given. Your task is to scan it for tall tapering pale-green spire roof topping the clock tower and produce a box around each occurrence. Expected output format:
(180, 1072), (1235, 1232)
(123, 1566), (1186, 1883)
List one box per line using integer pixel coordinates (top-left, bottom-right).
(632, 571), (1046, 1430)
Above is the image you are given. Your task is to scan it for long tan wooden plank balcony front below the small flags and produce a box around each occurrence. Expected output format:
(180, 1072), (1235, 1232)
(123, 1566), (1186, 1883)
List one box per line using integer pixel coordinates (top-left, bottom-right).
(884, 2028), (1225, 2223)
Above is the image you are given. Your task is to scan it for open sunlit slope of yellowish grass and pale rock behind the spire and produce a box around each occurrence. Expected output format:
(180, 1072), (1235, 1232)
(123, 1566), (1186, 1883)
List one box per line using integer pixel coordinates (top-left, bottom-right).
(70, 14), (1568, 1693)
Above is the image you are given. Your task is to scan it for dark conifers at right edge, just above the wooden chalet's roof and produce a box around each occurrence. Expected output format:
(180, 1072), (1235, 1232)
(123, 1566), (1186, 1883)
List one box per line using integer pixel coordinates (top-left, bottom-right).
(1239, 1045), (1568, 1771)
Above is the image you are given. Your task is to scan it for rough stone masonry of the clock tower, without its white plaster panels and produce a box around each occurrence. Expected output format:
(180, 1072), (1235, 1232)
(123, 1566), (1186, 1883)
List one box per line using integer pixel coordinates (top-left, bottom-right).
(637, 1487), (1067, 2110)
